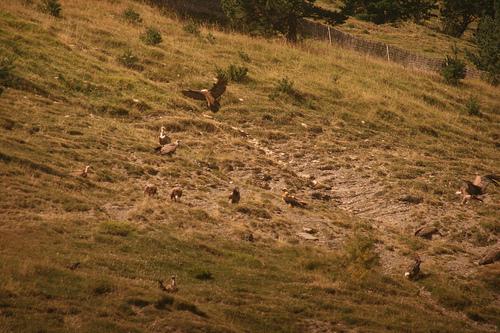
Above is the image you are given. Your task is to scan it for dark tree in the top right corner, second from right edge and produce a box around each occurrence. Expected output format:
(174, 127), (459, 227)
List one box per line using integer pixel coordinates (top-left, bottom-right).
(440, 0), (494, 37)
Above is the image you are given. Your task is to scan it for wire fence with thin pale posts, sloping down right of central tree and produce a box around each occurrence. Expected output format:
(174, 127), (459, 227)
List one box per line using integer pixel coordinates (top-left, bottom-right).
(301, 20), (482, 79)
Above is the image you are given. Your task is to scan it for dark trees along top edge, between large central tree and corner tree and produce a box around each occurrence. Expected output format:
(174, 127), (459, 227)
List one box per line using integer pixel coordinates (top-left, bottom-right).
(342, 0), (436, 24)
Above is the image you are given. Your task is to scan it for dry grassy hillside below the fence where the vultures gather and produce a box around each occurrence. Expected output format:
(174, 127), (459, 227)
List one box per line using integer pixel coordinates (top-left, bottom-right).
(0, 0), (500, 332)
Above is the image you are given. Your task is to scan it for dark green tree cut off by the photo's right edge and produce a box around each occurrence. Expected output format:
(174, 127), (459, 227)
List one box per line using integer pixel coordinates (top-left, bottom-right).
(469, 0), (500, 85)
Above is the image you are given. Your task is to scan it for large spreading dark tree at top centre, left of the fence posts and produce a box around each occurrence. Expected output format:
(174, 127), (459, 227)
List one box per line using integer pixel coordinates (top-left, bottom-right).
(222, 0), (344, 42)
